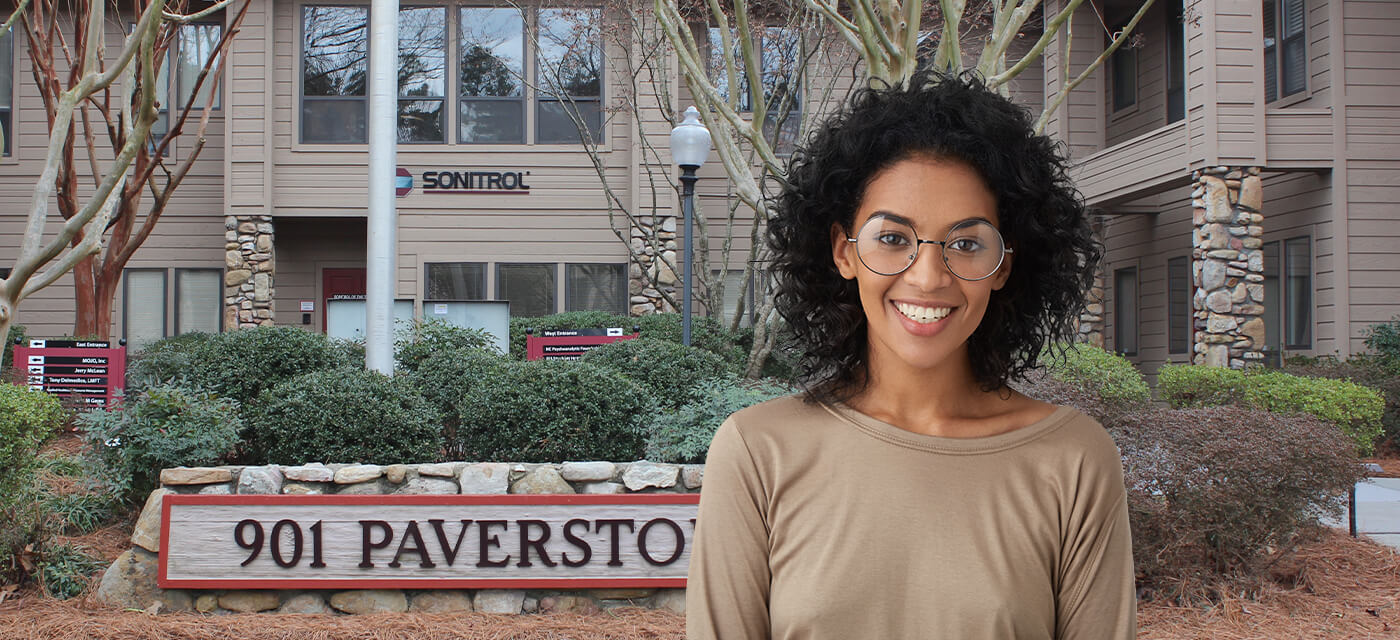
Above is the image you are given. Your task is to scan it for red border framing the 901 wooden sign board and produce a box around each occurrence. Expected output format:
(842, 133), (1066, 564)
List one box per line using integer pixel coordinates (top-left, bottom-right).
(155, 493), (700, 590)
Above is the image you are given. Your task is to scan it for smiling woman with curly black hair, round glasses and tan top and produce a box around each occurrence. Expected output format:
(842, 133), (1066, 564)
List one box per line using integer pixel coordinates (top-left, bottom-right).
(686, 74), (1135, 639)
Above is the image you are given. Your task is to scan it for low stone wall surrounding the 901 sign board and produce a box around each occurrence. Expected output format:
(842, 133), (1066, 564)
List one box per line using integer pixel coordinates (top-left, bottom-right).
(97, 461), (704, 613)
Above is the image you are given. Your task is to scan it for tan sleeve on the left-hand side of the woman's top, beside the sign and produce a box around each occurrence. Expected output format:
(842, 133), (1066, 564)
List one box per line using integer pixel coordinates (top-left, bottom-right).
(686, 419), (770, 640)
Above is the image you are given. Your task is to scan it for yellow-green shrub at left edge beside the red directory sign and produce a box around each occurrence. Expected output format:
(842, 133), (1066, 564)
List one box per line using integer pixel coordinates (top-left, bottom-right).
(0, 382), (64, 494)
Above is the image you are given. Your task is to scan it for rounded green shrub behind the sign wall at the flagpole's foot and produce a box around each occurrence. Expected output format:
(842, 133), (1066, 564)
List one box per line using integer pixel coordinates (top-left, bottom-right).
(249, 368), (442, 465)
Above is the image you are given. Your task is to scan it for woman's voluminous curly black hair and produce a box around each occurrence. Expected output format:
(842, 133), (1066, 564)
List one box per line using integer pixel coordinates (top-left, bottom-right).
(767, 73), (1103, 401)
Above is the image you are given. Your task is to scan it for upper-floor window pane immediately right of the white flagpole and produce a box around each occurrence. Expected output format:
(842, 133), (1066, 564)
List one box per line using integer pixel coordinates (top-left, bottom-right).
(398, 7), (447, 144)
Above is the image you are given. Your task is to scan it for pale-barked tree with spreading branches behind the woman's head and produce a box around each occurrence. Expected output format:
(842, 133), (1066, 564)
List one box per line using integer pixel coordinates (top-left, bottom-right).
(654, 0), (1152, 377)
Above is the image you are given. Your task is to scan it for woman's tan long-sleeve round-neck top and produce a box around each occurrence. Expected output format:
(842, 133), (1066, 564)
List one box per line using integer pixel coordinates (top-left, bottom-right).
(686, 396), (1135, 640)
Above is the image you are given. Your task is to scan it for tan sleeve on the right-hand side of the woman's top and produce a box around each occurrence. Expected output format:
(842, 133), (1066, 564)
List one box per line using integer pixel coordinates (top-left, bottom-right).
(1056, 434), (1137, 640)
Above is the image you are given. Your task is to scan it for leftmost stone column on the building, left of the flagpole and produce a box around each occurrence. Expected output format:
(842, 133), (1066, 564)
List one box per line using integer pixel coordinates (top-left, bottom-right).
(224, 216), (273, 331)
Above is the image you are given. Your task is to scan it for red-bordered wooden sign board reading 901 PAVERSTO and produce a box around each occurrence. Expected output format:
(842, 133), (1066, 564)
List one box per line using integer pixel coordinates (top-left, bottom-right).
(158, 493), (700, 590)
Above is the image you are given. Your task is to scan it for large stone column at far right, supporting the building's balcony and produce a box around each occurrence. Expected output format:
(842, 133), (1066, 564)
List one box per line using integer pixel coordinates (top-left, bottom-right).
(1191, 167), (1264, 368)
